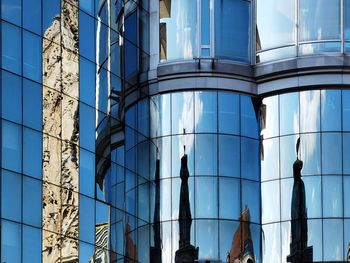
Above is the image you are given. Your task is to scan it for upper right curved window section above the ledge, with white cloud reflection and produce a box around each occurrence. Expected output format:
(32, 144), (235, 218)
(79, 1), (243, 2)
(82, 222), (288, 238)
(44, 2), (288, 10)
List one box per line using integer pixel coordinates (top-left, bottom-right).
(256, 0), (350, 63)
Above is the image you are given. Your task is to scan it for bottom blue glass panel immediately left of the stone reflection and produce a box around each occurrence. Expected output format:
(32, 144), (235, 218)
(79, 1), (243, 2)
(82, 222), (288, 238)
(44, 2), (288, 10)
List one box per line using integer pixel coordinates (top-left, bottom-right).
(22, 225), (42, 263)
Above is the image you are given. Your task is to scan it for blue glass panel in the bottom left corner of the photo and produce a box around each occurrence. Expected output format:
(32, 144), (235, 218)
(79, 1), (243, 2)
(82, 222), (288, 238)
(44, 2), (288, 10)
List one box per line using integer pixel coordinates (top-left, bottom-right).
(1, 220), (21, 263)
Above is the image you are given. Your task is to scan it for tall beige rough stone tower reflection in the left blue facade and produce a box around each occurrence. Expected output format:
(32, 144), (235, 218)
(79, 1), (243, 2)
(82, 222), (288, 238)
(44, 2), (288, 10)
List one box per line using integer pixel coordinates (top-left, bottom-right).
(42, 0), (79, 262)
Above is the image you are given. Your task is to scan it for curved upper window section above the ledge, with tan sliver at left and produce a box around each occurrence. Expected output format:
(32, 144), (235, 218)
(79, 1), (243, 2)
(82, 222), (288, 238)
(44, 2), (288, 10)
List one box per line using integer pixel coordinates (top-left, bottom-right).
(159, 0), (252, 63)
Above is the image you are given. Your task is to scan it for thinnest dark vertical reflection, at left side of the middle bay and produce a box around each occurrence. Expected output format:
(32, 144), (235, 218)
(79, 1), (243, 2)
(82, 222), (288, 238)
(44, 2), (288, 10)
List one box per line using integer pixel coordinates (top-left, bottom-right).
(150, 159), (162, 263)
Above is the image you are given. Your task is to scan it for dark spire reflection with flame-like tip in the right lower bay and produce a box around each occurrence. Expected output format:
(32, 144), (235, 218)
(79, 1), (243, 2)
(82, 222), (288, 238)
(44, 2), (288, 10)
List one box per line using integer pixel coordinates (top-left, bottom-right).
(287, 138), (313, 263)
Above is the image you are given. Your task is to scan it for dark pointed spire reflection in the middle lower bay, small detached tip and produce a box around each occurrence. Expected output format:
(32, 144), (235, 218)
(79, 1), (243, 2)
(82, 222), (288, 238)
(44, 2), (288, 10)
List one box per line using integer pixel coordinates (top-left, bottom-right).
(175, 144), (198, 263)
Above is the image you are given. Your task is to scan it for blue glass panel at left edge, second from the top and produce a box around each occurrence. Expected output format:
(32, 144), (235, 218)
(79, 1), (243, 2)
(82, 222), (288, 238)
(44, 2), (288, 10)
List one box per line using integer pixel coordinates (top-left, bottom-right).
(1, 22), (22, 74)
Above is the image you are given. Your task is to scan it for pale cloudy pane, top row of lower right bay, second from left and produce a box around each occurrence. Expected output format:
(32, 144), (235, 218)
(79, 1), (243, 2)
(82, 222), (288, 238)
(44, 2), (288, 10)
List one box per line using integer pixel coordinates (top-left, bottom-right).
(278, 92), (299, 135)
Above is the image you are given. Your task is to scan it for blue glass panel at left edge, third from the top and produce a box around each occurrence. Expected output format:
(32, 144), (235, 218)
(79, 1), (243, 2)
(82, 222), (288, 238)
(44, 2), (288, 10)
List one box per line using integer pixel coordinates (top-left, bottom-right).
(1, 71), (22, 123)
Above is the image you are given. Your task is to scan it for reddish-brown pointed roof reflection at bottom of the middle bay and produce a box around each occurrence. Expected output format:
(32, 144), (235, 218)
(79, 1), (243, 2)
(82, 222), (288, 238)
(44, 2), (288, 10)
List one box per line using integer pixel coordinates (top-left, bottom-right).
(226, 207), (255, 263)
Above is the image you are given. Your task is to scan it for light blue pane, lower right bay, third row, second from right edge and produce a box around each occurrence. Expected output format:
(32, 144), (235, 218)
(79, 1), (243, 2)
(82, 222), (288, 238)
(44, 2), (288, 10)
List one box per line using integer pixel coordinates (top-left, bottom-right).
(322, 176), (343, 217)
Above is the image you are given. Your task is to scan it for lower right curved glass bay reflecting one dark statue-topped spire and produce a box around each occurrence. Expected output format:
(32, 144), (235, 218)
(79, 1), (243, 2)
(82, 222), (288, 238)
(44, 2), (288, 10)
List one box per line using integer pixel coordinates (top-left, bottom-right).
(261, 89), (350, 262)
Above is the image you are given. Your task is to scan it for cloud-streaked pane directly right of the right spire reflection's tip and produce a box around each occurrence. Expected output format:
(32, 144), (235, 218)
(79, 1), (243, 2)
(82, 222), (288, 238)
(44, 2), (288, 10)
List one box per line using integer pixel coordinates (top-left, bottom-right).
(299, 134), (321, 175)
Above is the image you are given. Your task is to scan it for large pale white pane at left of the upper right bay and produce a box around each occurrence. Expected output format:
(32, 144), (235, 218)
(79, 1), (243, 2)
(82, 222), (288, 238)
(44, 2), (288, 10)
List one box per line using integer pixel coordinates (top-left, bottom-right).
(257, 0), (295, 50)
